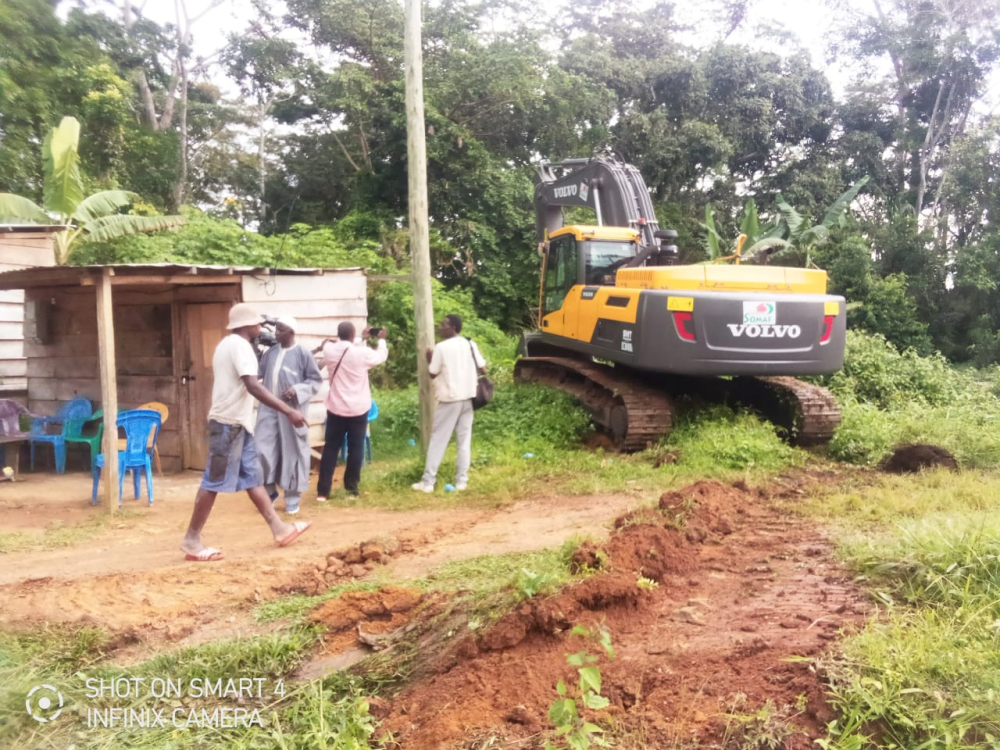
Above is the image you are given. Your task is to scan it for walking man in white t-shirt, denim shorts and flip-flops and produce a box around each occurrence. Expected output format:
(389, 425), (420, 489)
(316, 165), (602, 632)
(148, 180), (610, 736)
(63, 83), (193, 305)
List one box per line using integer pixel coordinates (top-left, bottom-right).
(181, 303), (311, 562)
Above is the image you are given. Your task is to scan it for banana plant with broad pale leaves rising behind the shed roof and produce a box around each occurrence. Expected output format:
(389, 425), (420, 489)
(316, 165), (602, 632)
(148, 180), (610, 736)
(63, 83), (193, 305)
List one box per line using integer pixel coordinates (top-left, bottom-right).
(0, 117), (184, 265)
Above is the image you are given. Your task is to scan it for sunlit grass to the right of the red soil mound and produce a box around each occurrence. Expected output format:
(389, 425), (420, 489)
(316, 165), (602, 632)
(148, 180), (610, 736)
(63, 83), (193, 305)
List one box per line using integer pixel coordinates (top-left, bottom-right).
(807, 471), (1000, 750)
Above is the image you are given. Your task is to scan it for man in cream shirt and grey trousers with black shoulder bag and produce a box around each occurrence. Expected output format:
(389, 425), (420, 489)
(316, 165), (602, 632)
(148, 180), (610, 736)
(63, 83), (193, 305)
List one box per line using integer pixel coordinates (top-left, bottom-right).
(413, 315), (486, 492)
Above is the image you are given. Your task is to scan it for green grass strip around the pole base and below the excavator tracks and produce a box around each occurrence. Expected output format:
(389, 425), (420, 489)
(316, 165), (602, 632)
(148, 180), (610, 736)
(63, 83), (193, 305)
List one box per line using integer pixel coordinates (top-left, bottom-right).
(327, 382), (808, 510)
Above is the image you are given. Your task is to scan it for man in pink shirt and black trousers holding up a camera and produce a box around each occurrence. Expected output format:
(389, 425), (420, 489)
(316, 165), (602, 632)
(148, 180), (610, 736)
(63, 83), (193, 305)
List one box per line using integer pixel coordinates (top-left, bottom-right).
(316, 323), (389, 503)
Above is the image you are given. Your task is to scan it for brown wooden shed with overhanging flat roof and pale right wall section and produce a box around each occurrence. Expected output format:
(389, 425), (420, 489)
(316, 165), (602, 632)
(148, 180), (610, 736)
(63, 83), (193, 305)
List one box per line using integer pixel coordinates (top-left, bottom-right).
(0, 263), (368, 488)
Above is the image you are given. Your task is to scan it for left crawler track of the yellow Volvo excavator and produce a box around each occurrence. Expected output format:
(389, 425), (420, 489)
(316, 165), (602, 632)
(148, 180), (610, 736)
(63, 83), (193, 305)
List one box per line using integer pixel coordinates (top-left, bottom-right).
(514, 357), (674, 452)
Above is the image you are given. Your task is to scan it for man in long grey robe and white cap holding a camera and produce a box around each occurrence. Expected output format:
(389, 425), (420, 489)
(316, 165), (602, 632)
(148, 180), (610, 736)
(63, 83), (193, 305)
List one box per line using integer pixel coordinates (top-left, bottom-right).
(255, 316), (323, 515)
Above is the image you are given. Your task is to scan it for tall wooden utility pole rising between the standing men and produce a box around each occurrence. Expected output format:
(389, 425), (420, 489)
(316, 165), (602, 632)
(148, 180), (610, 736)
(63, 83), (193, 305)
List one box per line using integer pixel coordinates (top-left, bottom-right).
(403, 0), (434, 450)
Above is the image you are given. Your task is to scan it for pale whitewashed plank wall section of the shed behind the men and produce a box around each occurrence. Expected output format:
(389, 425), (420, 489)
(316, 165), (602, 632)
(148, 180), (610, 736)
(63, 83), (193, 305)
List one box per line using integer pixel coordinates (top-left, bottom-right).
(243, 271), (368, 445)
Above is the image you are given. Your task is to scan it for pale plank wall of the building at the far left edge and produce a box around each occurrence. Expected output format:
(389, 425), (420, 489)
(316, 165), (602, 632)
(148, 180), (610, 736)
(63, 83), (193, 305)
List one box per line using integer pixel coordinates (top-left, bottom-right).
(0, 232), (55, 392)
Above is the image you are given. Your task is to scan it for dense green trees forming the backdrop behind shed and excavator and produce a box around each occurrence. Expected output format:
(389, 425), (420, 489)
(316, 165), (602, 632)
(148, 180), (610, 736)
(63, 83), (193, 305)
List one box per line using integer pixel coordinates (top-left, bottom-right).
(0, 0), (1000, 356)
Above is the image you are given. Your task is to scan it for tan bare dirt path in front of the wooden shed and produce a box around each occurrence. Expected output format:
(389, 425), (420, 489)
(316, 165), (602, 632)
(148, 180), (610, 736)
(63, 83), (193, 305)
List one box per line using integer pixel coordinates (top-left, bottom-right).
(0, 474), (637, 644)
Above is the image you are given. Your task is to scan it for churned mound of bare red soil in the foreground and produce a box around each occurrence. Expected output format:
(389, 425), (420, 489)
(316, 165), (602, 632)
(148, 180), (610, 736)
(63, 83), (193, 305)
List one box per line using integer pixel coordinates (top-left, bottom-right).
(372, 482), (861, 750)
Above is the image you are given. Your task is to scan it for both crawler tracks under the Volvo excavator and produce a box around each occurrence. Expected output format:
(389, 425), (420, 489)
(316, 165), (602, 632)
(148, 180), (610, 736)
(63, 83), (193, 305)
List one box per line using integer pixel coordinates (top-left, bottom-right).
(514, 357), (840, 452)
